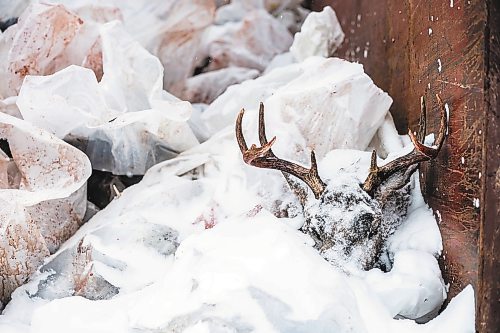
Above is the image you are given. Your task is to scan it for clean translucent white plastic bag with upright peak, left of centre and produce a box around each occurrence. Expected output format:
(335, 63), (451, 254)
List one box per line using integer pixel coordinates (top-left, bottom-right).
(17, 21), (198, 175)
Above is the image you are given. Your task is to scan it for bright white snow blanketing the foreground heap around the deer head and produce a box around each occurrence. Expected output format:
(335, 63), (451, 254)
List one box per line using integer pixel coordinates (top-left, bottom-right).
(0, 139), (474, 333)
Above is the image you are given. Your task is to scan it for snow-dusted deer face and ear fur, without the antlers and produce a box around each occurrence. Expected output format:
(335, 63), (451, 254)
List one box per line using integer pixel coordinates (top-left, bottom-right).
(302, 173), (410, 270)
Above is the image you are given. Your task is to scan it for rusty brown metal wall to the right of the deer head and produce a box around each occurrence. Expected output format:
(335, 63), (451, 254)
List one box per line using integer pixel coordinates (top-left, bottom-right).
(310, 0), (500, 332)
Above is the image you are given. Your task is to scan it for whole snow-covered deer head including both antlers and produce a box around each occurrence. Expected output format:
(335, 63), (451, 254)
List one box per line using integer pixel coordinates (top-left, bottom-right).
(236, 95), (447, 269)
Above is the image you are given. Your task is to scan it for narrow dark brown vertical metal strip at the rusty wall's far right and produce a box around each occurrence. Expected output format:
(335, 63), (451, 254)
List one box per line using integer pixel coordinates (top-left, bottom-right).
(478, 0), (500, 332)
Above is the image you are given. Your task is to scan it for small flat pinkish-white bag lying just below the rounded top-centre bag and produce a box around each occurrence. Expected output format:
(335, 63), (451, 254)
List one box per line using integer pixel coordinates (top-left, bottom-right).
(181, 67), (259, 104)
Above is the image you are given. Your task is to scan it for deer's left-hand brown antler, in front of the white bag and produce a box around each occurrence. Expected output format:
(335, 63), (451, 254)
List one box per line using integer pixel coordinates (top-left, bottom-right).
(236, 103), (326, 199)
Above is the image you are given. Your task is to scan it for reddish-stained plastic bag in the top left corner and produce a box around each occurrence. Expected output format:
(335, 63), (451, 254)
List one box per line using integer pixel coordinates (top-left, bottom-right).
(0, 3), (102, 98)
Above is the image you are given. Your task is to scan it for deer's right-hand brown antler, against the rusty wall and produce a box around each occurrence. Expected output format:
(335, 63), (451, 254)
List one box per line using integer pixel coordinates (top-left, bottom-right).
(363, 94), (448, 195)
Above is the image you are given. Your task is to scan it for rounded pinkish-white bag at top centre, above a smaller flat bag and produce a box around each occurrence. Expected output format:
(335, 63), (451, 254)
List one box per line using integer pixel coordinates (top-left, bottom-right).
(204, 9), (292, 71)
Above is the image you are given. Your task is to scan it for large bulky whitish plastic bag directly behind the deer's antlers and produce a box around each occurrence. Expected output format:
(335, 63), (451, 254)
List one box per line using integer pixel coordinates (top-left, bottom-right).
(202, 57), (392, 160)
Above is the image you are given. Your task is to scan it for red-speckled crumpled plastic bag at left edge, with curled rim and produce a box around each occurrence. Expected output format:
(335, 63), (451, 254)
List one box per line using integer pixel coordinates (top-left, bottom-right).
(0, 113), (91, 303)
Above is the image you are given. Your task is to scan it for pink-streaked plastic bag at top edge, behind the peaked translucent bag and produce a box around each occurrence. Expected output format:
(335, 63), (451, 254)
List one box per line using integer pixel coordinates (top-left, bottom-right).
(47, 0), (216, 96)
